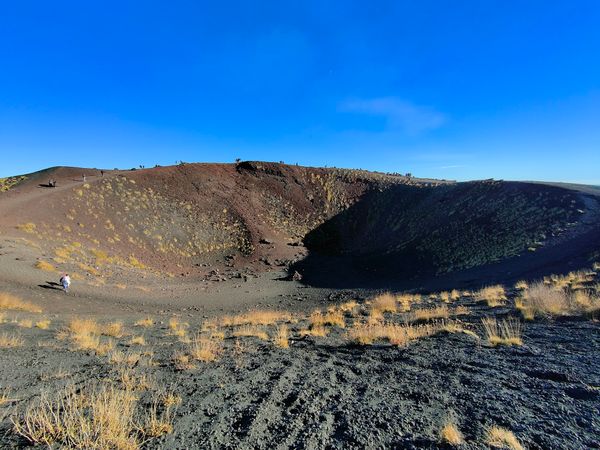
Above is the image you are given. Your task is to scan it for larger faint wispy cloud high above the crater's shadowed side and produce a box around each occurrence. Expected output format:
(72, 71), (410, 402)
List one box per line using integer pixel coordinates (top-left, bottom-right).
(338, 97), (447, 135)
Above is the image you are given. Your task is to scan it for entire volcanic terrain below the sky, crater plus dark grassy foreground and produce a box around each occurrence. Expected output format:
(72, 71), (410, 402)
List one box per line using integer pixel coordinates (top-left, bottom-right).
(0, 162), (600, 449)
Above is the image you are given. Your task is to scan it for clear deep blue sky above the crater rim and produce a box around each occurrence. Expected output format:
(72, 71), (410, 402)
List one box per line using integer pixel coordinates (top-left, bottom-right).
(0, 0), (600, 184)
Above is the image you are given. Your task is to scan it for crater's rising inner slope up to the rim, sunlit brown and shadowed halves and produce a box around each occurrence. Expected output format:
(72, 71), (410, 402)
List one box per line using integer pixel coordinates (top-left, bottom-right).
(0, 162), (598, 287)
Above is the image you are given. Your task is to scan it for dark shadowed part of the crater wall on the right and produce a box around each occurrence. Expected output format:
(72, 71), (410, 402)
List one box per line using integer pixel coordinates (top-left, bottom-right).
(292, 181), (596, 287)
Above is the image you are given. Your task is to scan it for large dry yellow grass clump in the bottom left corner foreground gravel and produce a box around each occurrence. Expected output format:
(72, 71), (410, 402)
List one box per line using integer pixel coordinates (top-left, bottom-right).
(13, 386), (150, 450)
